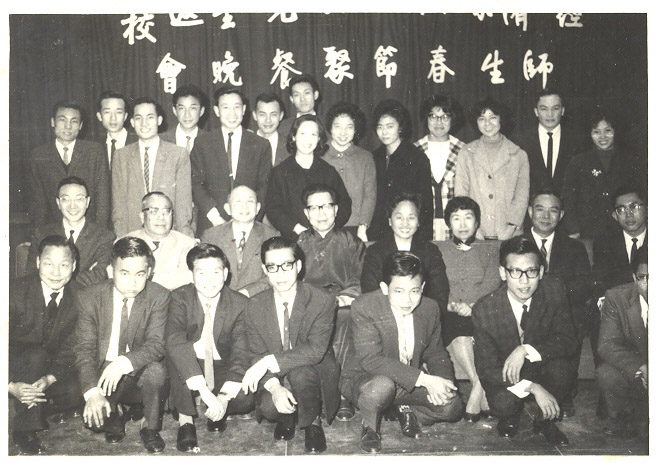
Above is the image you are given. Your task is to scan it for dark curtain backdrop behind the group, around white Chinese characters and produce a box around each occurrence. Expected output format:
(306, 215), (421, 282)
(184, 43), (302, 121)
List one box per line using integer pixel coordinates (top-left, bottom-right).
(9, 13), (647, 212)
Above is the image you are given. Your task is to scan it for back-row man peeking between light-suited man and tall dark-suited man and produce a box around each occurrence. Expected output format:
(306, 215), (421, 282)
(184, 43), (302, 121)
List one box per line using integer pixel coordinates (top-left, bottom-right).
(160, 84), (208, 154)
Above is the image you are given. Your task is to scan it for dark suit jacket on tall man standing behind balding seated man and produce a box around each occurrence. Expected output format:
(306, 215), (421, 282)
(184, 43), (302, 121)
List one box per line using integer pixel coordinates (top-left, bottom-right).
(190, 129), (272, 233)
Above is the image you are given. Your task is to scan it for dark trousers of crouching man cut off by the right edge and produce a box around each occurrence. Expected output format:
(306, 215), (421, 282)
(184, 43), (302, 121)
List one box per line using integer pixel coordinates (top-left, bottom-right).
(596, 362), (649, 418)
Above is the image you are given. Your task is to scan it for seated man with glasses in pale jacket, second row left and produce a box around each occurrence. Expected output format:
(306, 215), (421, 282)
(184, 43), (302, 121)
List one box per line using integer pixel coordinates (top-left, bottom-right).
(126, 191), (196, 291)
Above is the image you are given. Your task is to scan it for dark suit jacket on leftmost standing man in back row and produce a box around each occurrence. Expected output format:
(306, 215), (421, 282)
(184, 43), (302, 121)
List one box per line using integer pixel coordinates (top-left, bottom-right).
(25, 139), (110, 228)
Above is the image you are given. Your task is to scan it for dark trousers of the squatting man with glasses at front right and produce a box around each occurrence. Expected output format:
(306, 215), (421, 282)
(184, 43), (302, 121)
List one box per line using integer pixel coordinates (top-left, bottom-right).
(480, 357), (571, 420)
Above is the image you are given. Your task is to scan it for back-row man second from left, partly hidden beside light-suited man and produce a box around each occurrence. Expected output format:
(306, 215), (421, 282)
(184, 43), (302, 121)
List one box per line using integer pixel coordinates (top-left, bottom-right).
(96, 91), (137, 173)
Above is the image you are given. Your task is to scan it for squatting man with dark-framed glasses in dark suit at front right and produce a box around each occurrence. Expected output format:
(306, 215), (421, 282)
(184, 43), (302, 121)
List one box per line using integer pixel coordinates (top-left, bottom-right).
(472, 236), (577, 446)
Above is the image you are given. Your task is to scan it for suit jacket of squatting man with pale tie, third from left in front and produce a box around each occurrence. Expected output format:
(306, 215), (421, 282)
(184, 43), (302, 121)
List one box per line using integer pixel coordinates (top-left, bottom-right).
(165, 283), (249, 381)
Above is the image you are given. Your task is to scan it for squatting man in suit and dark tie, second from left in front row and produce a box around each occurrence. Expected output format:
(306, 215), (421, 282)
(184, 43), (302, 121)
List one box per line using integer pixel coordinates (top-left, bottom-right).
(75, 237), (170, 453)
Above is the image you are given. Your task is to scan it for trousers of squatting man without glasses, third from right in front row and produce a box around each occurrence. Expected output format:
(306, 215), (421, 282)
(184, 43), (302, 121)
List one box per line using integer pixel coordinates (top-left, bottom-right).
(345, 375), (464, 430)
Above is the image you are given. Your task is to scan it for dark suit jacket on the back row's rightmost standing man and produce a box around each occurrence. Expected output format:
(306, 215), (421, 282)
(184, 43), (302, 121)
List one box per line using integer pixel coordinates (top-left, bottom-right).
(518, 124), (581, 198)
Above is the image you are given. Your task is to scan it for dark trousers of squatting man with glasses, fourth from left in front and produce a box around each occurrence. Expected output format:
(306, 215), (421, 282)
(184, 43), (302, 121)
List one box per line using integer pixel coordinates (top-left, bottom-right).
(256, 366), (322, 428)
